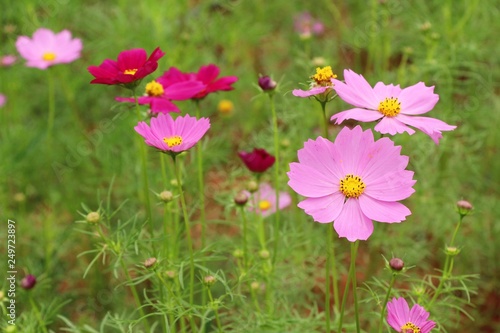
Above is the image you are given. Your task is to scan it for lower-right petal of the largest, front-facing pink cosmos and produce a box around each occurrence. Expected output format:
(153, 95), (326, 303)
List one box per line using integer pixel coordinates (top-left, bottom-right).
(359, 195), (411, 223)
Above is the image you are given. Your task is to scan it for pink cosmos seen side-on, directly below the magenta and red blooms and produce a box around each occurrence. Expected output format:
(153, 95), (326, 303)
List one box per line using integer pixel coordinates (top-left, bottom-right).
(134, 113), (210, 155)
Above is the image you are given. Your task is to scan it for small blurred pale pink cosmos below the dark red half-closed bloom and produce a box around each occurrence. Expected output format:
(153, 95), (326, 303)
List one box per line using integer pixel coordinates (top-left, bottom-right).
(244, 183), (292, 217)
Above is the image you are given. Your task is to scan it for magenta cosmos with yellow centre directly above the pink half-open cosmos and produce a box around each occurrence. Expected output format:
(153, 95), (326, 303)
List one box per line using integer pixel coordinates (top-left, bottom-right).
(116, 77), (206, 113)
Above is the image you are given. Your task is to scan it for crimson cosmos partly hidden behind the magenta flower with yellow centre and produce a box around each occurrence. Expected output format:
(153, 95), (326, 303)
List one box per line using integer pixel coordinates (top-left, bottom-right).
(162, 64), (238, 99)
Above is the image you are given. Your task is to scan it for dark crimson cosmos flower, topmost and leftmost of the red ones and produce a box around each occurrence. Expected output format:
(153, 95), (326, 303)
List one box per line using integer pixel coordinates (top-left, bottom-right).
(87, 47), (165, 88)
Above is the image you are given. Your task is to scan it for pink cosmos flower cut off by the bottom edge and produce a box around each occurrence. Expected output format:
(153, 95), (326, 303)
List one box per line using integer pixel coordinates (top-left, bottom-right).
(387, 297), (436, 333)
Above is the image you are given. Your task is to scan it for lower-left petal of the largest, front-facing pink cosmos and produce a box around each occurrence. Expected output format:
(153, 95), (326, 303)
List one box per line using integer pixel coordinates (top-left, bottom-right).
(298, 192), (345, 223)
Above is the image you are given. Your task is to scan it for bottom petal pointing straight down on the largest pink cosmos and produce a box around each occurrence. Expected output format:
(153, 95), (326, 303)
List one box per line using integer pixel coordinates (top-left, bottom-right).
(333, 198), (373, 242)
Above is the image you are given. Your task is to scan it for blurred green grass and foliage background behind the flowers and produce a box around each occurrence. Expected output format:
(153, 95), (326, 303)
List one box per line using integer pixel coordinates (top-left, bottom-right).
(0, 0), (500, 332)
